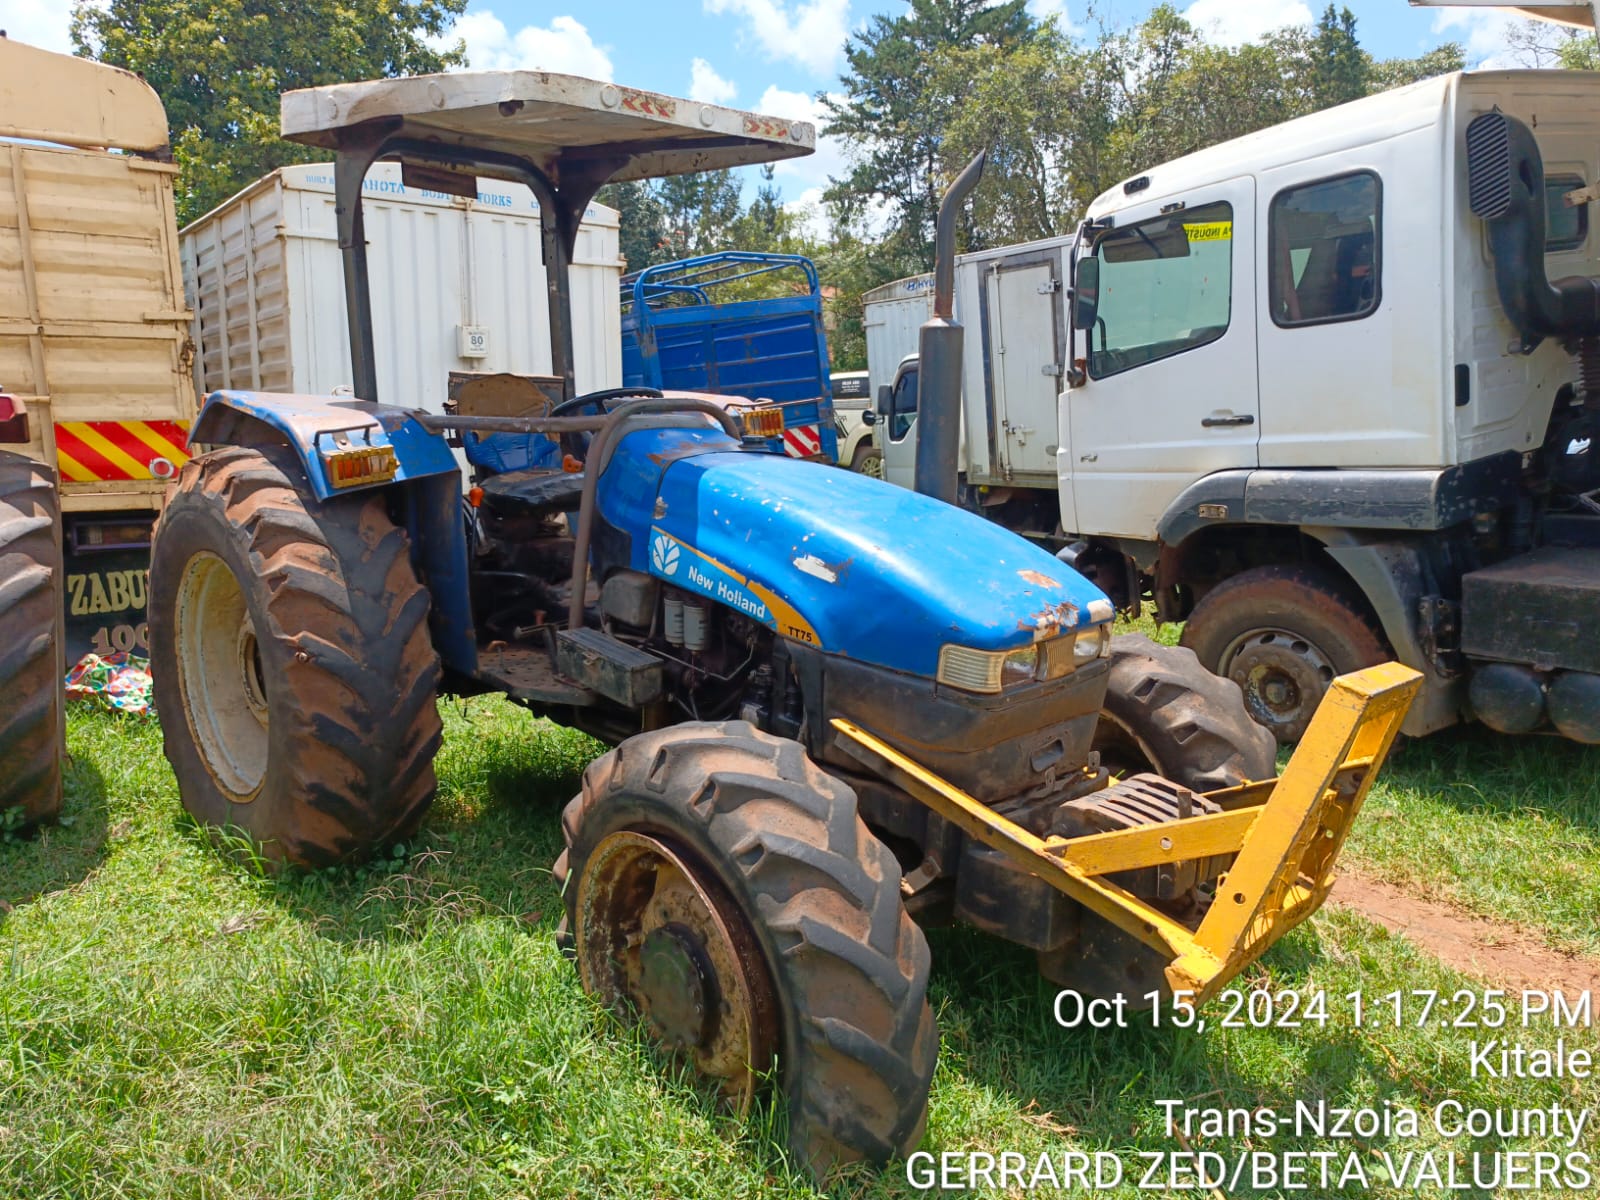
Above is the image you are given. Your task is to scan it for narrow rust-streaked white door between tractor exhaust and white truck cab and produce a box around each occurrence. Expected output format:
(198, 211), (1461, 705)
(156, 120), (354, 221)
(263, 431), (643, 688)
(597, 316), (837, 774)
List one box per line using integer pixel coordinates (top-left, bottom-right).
(984, 250), (1064, 480)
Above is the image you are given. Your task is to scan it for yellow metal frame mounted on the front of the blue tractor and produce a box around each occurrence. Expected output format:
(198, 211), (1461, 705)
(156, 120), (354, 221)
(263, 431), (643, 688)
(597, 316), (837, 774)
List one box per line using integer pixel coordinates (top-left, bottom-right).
(832, 662), (1422, 1005)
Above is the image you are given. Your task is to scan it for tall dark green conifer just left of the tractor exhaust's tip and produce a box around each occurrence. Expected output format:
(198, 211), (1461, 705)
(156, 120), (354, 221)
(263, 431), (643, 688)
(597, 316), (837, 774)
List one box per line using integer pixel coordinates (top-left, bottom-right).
(819, 0), (1037, 262)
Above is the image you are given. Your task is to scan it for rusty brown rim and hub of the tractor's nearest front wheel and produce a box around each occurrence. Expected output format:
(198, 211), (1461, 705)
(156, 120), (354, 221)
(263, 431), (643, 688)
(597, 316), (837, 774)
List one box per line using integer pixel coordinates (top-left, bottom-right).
(576, 830), (778, 1114)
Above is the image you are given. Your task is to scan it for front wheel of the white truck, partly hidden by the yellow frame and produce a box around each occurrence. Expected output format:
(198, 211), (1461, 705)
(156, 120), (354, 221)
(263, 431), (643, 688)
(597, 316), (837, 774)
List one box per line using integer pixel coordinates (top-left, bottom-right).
(1182, 566), (1390, 746)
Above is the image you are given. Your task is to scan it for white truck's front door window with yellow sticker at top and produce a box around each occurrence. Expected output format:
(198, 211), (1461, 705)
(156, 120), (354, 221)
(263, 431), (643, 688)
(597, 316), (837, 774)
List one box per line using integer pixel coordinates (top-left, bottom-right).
(1088, 203), (1234, 379)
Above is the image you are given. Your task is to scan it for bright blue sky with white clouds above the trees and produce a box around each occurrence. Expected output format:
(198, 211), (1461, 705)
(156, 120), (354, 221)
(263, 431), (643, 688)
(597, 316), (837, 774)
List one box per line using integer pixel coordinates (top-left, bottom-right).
(0, 0), (1536, 219)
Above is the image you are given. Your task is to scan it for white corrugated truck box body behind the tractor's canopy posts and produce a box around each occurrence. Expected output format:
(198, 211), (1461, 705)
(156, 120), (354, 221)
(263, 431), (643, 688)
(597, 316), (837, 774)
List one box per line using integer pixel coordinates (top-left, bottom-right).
(182, 163), (622, 411)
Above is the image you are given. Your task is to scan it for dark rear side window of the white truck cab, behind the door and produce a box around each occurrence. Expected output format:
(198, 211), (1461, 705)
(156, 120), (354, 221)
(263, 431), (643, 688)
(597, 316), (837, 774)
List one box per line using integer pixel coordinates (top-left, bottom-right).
(1267, 171), (1381, 326)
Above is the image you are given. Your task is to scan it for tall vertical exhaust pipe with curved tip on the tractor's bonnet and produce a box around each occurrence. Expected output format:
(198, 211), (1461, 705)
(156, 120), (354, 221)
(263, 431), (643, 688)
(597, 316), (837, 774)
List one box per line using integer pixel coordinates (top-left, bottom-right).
(917, 150), (987, 504)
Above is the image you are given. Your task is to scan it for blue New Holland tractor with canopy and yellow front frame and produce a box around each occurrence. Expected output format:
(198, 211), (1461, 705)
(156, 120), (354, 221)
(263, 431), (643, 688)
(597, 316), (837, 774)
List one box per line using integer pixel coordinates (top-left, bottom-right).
(150, 72), (1416, 1174)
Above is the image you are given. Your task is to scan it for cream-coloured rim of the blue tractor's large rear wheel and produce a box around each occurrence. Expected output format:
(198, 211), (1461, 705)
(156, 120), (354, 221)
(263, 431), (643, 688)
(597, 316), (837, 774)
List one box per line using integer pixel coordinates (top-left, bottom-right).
(174, 550), (269, 803)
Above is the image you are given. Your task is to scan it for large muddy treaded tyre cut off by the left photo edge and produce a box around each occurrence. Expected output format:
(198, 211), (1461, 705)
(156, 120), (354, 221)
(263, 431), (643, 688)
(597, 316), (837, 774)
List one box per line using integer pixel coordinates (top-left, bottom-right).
(0, 453), (67, 830)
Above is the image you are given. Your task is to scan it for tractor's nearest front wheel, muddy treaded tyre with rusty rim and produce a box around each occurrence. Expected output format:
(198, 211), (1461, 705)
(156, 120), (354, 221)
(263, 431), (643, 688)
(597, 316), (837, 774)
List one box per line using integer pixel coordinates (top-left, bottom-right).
(555, 722), (939, 1179)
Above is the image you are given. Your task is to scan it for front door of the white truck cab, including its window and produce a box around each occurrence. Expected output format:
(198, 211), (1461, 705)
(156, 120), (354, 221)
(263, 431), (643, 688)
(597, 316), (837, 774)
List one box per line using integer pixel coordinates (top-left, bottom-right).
(1061, 176), (1259, 539)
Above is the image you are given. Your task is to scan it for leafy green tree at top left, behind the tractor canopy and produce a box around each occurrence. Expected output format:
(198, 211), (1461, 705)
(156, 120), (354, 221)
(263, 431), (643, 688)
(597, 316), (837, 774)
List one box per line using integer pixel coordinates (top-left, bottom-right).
(72, 0), (466, 222)
